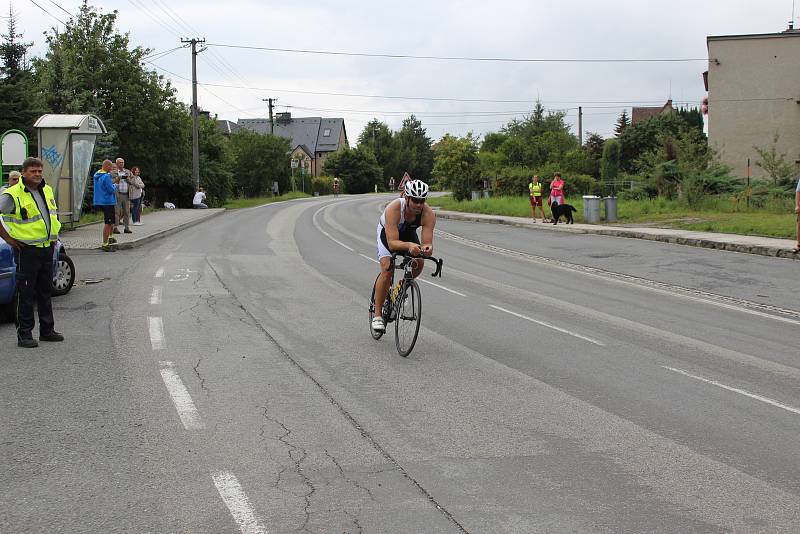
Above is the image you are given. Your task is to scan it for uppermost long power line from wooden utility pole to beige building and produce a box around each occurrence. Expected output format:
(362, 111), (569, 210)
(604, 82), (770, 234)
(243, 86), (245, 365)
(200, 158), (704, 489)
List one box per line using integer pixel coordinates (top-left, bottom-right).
(206, 43), (708, 63)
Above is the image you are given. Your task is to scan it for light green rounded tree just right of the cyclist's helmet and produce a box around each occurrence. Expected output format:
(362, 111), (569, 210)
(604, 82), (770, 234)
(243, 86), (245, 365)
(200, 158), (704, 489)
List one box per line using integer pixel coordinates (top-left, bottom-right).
(433, 132), (480, 201)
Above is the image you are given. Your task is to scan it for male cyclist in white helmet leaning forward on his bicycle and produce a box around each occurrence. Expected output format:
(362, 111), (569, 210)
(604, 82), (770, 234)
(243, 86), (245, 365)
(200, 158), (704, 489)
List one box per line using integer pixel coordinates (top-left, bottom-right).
(372, 180), (436, 332)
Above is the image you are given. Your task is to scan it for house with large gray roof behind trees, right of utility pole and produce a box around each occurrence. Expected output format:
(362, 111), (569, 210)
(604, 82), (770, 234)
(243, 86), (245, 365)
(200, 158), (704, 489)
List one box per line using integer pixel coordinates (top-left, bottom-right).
(237, 112), (349, 176)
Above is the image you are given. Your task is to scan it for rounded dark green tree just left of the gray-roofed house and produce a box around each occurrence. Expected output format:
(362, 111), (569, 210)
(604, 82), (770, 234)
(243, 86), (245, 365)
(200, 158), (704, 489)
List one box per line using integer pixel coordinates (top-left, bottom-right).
(230, 128), (291, 197)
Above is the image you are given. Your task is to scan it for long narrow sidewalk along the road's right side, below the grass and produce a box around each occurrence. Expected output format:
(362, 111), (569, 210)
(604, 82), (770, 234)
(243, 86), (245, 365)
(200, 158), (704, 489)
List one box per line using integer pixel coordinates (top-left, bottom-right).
(436, 209), (800, 260)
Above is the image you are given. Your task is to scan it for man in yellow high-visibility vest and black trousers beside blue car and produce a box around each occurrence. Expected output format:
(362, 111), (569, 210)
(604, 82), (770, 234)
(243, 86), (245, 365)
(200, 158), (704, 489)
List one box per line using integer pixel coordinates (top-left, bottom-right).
(0, 158), (64, 349)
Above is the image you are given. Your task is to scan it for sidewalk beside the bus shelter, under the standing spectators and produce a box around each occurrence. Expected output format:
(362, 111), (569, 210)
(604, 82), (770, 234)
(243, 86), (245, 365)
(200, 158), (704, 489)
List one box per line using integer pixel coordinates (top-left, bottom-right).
(61, 208), (225, 250)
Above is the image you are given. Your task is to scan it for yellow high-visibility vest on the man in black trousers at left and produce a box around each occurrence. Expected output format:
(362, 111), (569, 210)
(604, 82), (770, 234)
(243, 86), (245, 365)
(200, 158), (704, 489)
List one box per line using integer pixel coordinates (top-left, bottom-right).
(2, 180), (61, 246)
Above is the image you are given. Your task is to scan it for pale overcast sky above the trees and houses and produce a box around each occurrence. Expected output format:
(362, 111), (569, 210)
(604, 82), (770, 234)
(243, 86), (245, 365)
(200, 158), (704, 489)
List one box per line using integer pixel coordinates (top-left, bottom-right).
(7, 0), (800, 144)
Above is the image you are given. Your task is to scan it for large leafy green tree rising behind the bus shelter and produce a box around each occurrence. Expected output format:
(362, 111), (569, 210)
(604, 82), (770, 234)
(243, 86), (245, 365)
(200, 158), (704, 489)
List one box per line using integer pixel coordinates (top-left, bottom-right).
(33, 0), (192, 189)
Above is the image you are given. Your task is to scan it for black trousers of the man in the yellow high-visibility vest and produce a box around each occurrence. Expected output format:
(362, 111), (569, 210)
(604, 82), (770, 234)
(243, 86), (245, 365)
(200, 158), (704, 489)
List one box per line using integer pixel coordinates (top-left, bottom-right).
(14, 245), (55, 339)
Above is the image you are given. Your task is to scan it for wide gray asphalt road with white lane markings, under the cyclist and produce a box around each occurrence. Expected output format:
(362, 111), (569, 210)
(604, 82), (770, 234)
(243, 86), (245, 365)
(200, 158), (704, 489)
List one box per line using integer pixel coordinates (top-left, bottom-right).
(0, 196), (800, 533)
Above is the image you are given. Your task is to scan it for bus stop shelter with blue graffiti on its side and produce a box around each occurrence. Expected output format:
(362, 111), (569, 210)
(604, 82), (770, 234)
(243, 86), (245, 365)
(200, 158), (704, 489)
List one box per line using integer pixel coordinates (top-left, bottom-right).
(33, 114), (106, 223)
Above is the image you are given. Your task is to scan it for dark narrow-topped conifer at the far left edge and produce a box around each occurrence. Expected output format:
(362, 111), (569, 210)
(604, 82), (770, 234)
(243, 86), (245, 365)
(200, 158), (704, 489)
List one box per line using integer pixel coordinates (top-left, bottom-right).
(0, 9), (45, 154)
